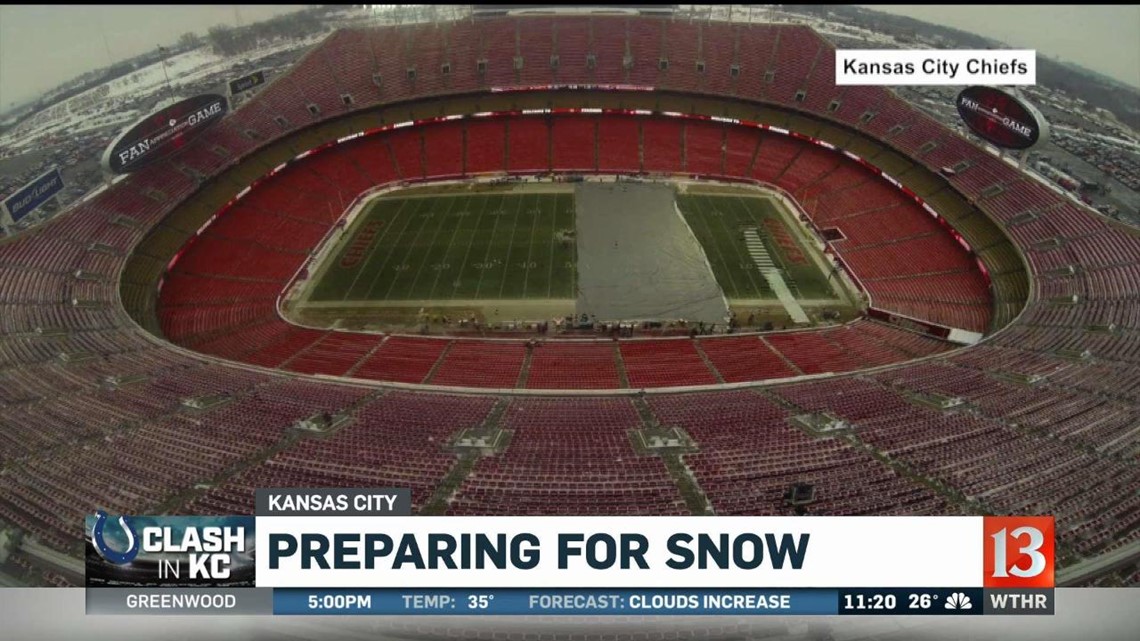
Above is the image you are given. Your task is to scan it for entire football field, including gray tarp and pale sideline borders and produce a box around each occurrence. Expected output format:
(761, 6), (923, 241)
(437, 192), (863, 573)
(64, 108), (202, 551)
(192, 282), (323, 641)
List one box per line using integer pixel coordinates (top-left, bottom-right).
(294, 182), (846, 330)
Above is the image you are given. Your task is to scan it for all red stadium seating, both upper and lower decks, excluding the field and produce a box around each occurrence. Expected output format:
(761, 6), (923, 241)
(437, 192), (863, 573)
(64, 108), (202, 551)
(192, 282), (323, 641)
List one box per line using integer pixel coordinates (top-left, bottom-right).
(0, 17), (1140, 585)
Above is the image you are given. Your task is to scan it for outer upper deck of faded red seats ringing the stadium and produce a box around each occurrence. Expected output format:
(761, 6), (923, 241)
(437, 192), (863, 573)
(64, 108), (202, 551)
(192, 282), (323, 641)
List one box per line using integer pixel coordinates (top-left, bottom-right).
(0, 17), (1140, 584)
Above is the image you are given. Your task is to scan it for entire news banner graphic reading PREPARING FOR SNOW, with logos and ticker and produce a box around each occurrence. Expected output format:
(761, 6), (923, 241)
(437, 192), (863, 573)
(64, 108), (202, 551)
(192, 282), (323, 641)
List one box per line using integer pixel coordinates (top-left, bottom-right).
(86, 488), (1055, 616)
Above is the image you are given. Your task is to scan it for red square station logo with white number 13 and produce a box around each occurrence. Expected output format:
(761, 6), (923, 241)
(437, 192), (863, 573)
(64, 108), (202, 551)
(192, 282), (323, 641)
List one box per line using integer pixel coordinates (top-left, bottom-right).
(983, 517), (1055, 587)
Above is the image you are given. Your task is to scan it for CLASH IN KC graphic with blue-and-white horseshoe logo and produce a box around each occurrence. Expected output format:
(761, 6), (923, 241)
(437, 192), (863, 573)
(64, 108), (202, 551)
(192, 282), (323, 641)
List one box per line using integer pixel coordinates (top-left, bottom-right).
(86, 511), (255, 587)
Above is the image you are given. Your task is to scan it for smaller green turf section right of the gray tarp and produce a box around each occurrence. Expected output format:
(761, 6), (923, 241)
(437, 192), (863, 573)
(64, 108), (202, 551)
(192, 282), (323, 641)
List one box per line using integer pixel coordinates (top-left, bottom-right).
(677, 194), (834, 299)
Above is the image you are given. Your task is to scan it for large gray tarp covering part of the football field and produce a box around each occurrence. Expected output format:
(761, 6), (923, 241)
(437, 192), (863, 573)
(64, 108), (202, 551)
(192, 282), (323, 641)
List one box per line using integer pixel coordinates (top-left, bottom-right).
(575, 182), (727, 323)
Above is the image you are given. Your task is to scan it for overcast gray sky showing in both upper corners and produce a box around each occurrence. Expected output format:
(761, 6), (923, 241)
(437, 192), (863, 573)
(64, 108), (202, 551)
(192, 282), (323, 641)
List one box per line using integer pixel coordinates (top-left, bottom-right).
(0, 5), (1140, 112)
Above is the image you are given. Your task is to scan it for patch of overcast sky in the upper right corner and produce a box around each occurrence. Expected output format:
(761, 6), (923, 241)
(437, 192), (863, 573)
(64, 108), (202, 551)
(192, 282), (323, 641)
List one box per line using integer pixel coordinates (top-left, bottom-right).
(863, 5), (1140, 87)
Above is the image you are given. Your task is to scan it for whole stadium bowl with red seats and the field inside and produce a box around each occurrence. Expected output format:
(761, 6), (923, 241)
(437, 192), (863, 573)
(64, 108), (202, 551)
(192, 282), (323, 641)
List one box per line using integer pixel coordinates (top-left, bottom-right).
(0, 7), (1140, 597)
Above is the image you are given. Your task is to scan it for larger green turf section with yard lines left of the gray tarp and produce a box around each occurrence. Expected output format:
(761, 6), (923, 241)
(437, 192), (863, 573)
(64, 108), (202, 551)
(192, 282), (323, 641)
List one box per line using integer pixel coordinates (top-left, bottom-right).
(309, 192), (577, 302)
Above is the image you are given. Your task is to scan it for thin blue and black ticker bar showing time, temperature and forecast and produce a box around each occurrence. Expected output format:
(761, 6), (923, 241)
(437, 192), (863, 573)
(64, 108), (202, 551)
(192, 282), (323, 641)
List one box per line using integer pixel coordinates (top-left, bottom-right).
(274, 587), (982, 616)
